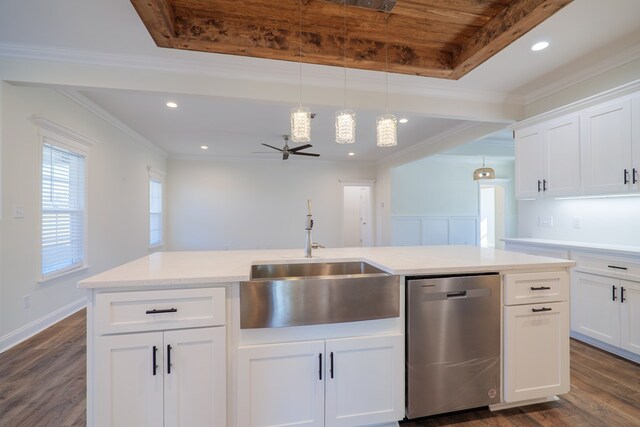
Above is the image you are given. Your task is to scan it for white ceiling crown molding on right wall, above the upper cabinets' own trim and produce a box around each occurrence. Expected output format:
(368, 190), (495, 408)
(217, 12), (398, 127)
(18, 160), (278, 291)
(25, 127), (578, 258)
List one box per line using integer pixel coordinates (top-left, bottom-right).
(524, 44), (640, 104)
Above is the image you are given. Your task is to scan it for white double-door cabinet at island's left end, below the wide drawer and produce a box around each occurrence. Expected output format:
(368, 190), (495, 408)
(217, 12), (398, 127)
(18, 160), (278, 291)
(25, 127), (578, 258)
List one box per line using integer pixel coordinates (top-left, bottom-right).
(94, 326), (226, 427)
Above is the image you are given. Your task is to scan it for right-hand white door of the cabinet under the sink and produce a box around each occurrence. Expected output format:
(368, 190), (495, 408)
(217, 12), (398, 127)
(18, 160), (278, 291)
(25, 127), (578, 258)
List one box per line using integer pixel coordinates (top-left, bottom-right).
(326, 334), (404, 427)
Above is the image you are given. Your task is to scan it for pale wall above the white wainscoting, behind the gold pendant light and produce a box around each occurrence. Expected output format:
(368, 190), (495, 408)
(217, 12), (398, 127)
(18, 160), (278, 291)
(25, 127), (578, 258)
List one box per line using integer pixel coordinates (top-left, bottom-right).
(391, 156), (517, 244)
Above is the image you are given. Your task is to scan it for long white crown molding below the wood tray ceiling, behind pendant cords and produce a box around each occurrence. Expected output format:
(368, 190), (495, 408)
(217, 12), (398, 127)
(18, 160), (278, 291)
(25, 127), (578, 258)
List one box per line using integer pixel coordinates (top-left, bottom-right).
(0, 42), (524, 105)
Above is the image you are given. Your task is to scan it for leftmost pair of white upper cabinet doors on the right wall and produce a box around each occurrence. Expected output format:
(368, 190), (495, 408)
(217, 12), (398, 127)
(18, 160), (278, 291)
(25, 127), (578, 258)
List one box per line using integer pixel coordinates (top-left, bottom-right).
(515, 115), (580, 198)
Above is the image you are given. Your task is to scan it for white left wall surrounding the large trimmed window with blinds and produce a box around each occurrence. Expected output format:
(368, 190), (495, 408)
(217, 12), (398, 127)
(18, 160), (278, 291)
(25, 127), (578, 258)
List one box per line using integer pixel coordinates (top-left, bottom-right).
(0, 82), (166, 350)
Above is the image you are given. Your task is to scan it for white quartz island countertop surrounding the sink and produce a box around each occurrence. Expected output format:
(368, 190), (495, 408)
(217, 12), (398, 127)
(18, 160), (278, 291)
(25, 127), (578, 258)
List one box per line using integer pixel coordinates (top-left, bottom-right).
(78, 246), (575, 288)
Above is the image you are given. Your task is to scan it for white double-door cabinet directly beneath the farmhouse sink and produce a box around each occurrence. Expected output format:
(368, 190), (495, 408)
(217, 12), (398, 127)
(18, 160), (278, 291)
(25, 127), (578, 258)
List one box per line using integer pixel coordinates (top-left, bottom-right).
(238, 334), (404, 427)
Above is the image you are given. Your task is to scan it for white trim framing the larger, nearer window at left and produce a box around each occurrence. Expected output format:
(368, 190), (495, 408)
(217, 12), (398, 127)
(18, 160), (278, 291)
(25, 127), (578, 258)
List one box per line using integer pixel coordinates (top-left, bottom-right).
(31, 116), (98, 283)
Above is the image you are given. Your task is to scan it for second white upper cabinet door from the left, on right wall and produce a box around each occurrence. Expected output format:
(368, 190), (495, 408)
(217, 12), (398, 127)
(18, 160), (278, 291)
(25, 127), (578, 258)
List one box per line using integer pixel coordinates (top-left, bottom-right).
(542, 115), (580, 196)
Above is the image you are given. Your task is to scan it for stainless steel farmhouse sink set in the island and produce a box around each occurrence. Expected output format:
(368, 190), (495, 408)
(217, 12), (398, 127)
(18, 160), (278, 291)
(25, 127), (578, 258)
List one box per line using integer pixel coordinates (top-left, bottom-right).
(240, 261), (400, 329)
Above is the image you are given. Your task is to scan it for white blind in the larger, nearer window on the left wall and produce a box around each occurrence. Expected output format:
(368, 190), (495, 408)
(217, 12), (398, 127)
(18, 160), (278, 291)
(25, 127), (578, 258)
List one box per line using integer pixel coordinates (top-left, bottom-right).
(41, 143), (85, 277)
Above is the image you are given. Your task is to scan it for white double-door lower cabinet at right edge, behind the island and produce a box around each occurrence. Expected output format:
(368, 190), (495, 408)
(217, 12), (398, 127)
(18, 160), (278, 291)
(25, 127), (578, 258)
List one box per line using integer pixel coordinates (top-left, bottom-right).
(571, 272), (640, 355)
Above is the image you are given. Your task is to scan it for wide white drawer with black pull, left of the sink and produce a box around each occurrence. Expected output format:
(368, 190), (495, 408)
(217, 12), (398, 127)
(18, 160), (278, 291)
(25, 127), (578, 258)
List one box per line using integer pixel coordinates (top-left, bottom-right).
(95, 288), (226, 335)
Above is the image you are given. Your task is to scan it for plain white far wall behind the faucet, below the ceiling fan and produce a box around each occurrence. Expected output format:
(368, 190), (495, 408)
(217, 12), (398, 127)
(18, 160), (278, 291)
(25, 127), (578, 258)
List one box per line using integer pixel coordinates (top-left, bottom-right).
(167, 159), (375, 254)
